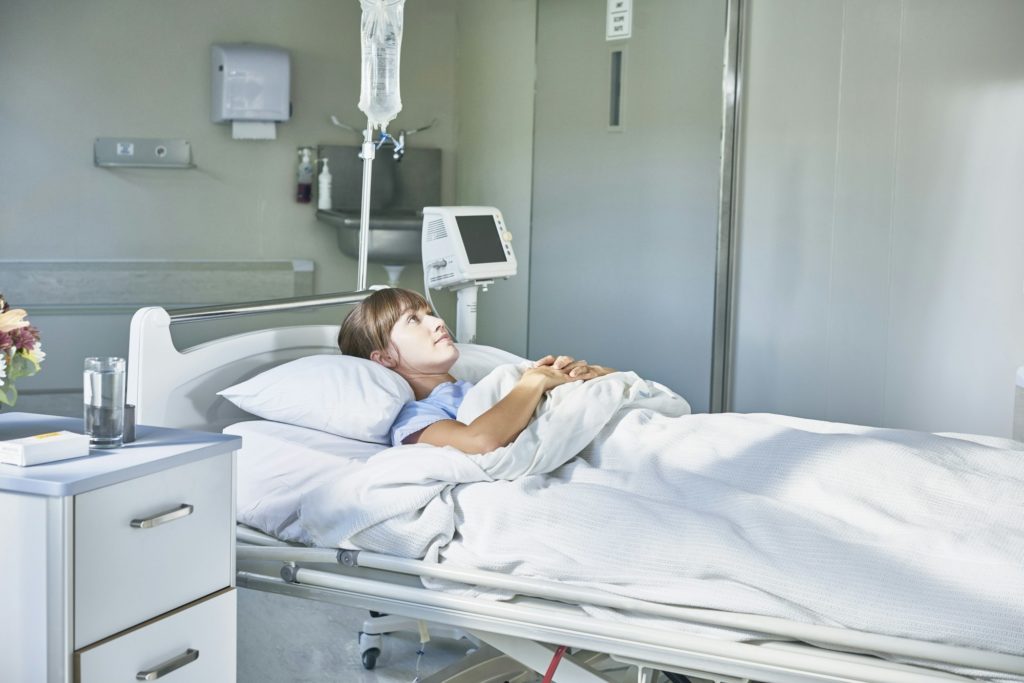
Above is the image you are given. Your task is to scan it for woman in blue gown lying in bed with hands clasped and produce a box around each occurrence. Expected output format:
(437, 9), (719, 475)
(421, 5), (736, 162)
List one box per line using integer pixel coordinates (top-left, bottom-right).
(338, 289), (614, 454)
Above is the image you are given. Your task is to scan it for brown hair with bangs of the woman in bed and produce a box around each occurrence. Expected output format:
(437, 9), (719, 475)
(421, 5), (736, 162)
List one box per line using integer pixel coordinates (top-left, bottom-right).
(338, 289), (430, 358)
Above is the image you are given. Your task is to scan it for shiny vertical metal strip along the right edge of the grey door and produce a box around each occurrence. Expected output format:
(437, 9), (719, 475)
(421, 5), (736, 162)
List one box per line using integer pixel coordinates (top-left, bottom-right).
(711, 0), (746, 413)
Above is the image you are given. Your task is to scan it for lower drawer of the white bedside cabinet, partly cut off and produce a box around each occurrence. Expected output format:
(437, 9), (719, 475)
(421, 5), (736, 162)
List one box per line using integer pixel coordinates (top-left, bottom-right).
(75, 589), (236, 683)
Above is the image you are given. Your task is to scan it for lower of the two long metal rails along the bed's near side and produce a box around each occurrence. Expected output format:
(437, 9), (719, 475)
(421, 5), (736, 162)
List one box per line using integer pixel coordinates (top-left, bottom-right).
(238, 566), (974, 683)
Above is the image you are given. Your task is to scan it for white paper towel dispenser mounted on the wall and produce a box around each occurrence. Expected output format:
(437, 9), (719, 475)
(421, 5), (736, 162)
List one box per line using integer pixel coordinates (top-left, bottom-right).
(210, 43), (292, 140)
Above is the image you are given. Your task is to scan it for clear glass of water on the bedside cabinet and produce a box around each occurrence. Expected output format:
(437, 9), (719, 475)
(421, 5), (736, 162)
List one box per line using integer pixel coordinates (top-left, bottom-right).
(82, 357), (125, 449)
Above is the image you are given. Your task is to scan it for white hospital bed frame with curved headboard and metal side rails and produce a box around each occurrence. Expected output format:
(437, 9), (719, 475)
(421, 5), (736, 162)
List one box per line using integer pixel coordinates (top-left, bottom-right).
(128, 292), (1024, 683)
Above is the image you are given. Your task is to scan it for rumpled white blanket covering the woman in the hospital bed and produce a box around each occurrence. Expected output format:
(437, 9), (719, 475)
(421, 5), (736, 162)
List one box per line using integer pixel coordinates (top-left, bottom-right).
(300, 367), (1024, 653)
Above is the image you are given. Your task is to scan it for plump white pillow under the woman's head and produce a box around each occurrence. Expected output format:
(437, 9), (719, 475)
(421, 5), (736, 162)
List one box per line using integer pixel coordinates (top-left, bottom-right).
(217, 354), (414, 443)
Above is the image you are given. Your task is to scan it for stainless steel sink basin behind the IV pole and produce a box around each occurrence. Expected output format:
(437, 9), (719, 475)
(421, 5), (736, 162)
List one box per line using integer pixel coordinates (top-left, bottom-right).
(316, 209), (423, 265)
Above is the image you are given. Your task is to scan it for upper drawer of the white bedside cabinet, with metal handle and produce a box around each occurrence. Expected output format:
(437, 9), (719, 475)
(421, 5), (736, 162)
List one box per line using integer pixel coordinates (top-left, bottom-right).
(75, 454), (234, 648)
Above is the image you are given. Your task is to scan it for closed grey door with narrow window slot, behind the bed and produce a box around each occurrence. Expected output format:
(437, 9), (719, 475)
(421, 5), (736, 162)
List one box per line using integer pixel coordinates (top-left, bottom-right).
(528, 0), (726, 412)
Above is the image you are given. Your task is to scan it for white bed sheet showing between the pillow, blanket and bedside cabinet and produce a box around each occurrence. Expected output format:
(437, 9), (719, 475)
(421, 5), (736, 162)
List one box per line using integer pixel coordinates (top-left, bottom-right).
(224, 420), (387, 545)
